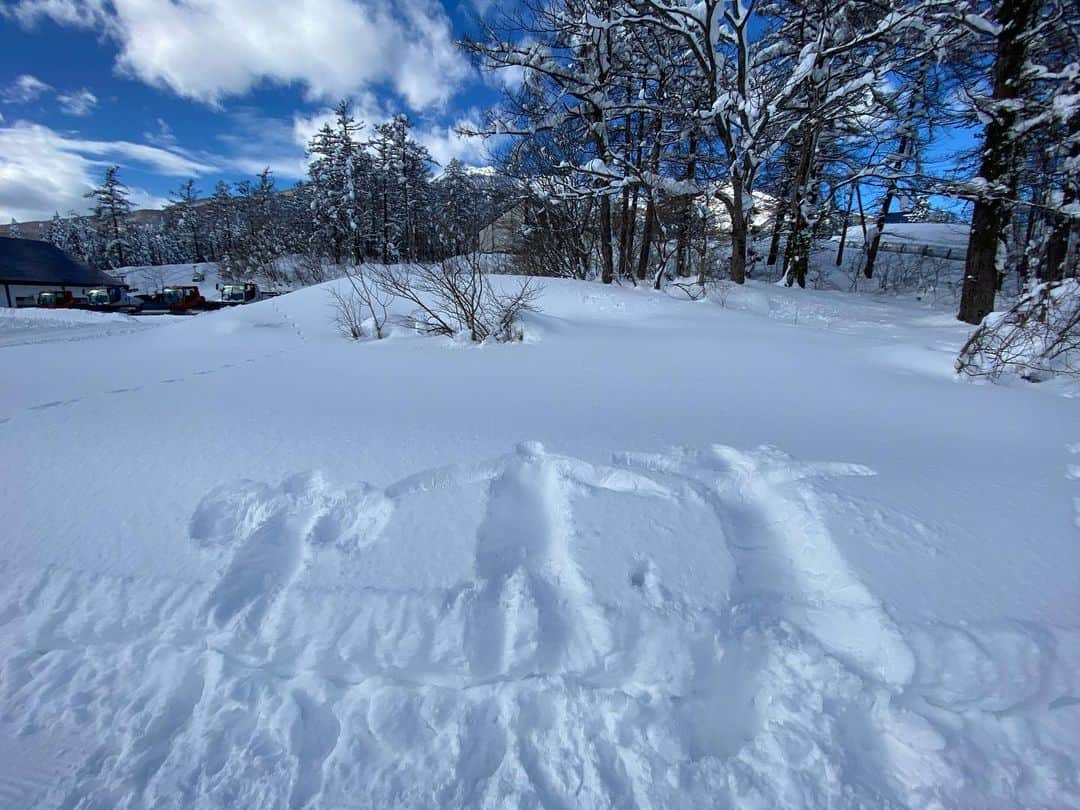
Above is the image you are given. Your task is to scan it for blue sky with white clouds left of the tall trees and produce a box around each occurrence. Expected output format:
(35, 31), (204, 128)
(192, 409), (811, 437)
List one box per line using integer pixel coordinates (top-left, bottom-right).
(0, 0), (498, 222)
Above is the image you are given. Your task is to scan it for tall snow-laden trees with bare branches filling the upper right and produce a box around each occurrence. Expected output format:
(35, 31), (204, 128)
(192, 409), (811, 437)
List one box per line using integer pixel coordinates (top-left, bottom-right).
(465, 0), (1080, 323)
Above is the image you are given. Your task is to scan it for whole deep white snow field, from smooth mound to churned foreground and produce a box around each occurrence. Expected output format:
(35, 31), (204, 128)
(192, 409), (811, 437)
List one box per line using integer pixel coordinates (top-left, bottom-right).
(0, 279), (1080, 810)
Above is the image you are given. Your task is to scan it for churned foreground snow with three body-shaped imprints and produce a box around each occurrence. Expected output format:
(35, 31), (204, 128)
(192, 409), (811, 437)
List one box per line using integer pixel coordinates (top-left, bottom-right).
(0, 442), (1080, 808)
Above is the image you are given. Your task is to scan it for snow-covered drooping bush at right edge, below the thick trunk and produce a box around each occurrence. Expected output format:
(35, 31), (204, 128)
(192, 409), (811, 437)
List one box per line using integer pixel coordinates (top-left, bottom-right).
(956, 279), (1080, 382)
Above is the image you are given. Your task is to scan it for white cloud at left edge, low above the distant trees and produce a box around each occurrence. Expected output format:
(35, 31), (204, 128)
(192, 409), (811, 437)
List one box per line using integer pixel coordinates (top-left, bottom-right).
(0, 121), (215, 221)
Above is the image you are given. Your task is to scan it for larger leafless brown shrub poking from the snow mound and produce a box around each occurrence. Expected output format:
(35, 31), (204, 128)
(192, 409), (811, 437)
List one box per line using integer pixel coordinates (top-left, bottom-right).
(375, 255), (540, 342)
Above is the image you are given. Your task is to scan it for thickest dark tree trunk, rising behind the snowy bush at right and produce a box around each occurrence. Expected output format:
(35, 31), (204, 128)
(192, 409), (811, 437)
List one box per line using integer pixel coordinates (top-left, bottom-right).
(957, 0), (1038, 325)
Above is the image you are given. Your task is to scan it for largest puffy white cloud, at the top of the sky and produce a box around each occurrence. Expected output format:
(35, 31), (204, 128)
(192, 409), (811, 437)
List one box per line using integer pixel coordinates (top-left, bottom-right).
(4, 0), (469, 110)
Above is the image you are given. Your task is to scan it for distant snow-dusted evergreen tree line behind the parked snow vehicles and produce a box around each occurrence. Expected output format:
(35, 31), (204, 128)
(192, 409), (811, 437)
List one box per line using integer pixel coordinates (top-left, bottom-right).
(35, 110), (513, 278)
